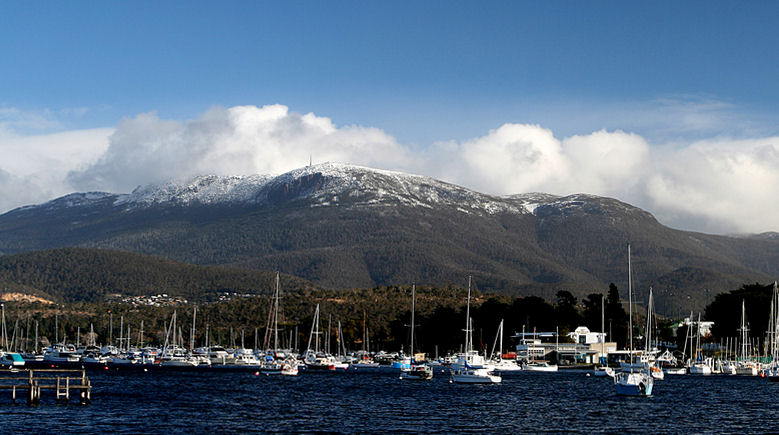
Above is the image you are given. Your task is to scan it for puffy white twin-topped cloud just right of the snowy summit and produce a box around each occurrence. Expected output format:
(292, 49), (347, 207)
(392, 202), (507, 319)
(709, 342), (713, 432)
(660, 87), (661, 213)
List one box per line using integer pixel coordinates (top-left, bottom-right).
(427, 124), (651, 197)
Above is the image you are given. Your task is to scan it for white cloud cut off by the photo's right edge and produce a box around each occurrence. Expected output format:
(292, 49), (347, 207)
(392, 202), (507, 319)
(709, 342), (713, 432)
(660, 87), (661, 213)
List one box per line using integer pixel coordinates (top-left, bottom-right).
(646, 137), (779, 233)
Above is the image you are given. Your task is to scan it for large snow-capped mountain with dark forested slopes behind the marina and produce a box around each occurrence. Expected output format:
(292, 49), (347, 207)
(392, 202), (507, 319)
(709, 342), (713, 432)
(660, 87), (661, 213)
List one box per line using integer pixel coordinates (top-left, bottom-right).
(0, 163), (779, 310)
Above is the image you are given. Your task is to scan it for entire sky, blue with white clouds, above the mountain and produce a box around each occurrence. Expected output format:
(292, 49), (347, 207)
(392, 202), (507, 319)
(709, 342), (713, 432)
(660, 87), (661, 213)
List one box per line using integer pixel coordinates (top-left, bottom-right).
(0, 0), (779, 234)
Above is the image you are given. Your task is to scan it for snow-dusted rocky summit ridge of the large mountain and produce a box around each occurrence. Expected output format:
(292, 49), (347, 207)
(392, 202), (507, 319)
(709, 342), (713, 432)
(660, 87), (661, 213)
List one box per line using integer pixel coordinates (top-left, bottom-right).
(25, 163), (616, 215)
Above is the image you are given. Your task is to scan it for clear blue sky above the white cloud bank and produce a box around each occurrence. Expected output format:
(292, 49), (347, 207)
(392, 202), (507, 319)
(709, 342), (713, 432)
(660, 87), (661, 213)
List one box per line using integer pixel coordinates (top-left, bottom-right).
(0, 1), (779, 235)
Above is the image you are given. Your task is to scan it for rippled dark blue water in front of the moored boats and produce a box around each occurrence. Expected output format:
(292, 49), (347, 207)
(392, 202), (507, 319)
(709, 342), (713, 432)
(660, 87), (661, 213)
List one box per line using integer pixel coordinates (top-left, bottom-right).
(0, 372), (779, 433)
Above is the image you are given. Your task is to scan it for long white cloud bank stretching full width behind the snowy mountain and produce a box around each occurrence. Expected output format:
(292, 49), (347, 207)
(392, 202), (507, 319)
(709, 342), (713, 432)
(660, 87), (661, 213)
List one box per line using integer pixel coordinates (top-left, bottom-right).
(0, 105), (779, 233)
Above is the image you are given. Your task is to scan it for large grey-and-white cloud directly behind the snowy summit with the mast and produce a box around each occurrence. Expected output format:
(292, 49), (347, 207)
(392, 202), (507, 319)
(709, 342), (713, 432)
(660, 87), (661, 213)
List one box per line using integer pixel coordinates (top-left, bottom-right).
(68, 105), (410, 192)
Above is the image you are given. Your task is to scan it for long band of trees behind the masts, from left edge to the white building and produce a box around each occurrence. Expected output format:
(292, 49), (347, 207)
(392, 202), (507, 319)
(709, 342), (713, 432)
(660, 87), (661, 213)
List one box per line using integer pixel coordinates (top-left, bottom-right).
(5, 284), (644, 355)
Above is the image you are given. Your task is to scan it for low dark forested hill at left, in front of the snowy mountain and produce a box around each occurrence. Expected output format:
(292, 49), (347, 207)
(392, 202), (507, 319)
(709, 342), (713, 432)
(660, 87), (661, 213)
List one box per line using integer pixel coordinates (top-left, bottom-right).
(0, 248), (319, 302)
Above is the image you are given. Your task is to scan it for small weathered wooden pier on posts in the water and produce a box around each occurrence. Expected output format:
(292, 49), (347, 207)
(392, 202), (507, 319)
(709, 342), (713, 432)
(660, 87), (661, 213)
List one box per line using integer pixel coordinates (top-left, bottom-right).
(0, 369), (92, 405)
